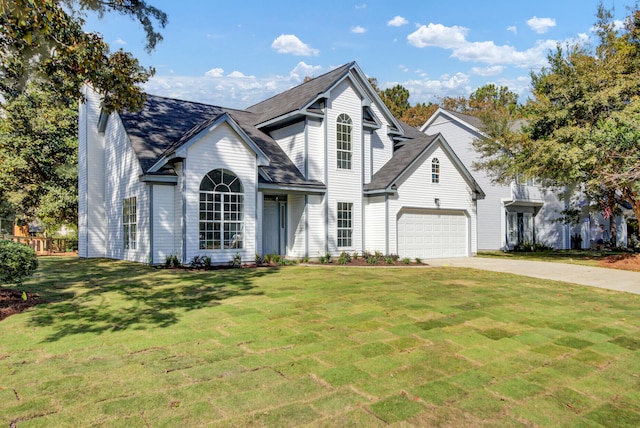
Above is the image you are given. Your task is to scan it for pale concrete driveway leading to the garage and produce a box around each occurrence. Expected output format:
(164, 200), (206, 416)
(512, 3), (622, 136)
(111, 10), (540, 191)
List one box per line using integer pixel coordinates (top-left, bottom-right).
(425, 257), (640, 294)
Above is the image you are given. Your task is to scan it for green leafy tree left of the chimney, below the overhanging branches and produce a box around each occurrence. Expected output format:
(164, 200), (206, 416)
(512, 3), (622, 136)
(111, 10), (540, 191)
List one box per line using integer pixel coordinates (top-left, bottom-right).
(0, 83), (78, 232)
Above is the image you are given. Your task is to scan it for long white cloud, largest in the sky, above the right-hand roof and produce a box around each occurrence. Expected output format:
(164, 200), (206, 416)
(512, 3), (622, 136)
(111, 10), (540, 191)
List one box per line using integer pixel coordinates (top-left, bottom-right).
(407, 24), (557, 68)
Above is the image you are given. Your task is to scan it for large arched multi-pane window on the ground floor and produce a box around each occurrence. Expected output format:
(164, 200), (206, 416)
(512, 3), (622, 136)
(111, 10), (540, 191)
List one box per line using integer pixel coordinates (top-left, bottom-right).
(199, 169), (244, 250)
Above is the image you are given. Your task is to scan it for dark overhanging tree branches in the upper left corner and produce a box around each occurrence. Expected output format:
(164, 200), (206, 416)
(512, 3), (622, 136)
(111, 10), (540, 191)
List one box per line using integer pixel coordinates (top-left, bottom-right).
(0, 0), (167, 112)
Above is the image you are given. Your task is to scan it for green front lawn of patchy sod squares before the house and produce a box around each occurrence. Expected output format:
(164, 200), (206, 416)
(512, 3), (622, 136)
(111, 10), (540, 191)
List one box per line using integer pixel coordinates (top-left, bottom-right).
(0, 258), (640, 427)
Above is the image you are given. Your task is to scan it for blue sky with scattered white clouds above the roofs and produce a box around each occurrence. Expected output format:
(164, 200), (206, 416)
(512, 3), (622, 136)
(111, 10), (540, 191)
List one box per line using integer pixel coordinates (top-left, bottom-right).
(85, 0), (632, 108)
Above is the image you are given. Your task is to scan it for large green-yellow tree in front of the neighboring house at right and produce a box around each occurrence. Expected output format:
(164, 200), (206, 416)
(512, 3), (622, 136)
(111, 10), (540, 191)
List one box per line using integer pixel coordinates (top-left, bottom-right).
(476, 3), (640, 244)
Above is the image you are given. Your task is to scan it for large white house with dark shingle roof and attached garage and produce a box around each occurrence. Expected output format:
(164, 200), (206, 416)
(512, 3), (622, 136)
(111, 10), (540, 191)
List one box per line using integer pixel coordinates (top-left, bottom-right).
(78, 63), (484, 264)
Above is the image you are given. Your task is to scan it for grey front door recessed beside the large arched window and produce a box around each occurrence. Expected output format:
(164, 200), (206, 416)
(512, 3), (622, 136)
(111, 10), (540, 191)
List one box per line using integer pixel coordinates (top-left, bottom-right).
(262, 196), (287, 256)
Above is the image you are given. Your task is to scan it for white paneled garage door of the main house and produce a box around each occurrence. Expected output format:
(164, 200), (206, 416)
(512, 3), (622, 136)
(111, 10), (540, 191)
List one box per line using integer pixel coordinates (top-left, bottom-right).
(398, 210), (469, 259)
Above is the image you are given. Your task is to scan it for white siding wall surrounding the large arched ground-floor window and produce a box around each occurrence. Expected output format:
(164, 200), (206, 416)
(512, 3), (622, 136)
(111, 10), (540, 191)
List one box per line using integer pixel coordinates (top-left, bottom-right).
(184, 123), (257, 264)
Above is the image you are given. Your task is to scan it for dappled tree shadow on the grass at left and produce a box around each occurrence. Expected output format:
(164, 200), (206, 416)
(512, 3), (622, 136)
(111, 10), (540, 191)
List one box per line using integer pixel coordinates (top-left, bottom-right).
(25, 258), (277, 342)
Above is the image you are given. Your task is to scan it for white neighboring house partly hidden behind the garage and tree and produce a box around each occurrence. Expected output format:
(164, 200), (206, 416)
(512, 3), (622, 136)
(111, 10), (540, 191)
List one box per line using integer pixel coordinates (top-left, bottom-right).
(420, 109), (626, 250)
